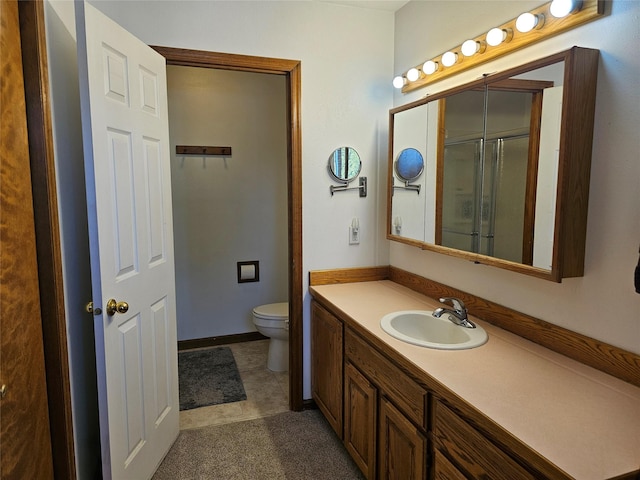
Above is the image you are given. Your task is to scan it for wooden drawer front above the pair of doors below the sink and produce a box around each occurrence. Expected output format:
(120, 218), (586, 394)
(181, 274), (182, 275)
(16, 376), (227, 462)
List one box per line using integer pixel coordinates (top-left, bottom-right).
(345, 329), (427, 429)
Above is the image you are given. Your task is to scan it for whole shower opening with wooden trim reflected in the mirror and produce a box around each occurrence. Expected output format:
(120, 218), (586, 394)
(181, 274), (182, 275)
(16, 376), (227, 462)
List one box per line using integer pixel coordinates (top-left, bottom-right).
(436, 83), (553, 265)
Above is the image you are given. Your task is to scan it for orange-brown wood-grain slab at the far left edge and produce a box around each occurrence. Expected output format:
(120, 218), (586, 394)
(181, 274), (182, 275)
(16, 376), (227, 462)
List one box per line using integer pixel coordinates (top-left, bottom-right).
(0, 0), (53, 479)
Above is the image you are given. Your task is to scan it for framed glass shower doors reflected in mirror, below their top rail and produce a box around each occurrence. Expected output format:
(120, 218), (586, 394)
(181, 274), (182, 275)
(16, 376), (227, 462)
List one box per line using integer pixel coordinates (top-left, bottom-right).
(441, 135), (532, 263)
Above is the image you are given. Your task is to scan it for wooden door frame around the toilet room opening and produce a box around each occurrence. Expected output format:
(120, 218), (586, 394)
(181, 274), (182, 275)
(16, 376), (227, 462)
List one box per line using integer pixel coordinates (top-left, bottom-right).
(151, 45), (303, 411)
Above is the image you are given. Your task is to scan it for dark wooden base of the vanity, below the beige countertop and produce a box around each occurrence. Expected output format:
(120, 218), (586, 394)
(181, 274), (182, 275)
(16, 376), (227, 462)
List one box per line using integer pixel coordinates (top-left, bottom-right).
(311, 300), (552, 480)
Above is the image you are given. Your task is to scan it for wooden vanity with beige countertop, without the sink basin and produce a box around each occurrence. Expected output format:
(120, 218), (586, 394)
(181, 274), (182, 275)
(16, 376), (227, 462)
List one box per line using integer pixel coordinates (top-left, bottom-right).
(310, 278), (640, 480)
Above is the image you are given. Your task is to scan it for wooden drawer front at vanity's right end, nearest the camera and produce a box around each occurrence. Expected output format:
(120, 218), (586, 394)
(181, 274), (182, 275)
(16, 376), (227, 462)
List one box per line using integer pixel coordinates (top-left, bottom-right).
(433, 402), (536, 480)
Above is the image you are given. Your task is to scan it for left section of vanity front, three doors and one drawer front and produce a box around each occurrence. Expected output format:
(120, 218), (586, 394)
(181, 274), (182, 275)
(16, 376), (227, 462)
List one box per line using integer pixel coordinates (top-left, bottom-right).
(311, 300), (428, 480)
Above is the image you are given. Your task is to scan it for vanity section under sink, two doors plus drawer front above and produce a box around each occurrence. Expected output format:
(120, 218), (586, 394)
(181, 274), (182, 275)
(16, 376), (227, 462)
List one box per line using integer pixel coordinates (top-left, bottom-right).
(344, 328), (427, 480)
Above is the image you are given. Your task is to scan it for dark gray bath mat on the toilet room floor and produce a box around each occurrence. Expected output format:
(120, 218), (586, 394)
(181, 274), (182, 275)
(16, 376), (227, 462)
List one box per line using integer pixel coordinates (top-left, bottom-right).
(178, 347), (247, 410)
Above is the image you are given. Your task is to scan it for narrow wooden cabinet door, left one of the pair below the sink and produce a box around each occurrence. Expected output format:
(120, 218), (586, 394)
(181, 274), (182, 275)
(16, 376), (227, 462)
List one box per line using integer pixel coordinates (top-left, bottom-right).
(344, 363), (377, 479)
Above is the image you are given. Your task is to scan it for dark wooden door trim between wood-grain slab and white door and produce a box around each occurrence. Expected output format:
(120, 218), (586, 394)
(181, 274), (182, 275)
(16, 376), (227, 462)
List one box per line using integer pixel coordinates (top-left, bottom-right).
(18, 0), (76, 479)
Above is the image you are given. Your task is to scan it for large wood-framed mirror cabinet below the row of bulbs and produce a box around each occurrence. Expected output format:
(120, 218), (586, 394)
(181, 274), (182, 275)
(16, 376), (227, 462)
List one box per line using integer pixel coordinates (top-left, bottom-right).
(388, 47), (598, 281)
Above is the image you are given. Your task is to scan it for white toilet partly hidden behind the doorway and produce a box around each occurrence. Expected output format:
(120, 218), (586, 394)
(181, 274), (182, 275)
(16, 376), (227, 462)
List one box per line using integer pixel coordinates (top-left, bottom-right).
(253, 302), (289, 372)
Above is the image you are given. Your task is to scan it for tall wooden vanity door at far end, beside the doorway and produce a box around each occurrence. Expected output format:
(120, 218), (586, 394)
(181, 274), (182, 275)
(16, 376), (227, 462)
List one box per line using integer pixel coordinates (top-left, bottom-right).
(311, 302), (343, 438)
